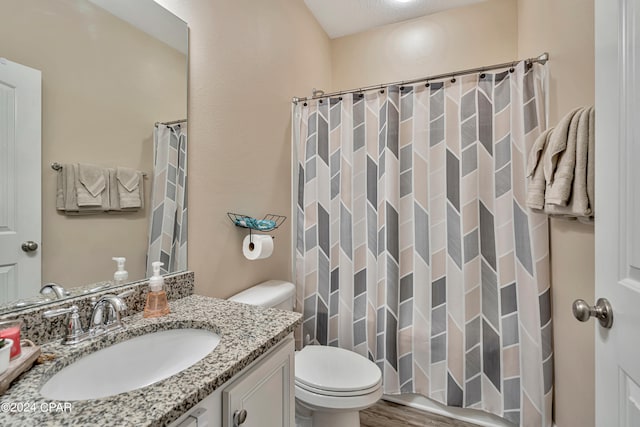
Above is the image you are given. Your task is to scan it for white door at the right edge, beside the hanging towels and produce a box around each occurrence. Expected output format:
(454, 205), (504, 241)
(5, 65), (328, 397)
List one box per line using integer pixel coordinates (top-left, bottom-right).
(596, 0), (640, 427)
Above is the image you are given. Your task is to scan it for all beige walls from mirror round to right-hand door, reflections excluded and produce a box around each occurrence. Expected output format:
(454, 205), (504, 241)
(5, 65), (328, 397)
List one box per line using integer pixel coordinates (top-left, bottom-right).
(152, 0), (594, 427)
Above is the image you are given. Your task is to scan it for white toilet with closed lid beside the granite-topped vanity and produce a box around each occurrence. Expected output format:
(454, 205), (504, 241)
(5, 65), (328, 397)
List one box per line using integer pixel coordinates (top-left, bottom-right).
(229, 280), (382, 427)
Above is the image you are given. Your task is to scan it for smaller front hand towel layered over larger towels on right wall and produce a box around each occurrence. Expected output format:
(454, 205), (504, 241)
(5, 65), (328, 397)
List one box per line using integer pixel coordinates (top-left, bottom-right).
(544, 108), (590, 206)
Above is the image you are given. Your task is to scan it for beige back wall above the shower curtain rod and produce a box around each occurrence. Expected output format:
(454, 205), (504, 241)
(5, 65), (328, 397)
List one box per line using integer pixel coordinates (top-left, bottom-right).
(331, 0), (518, 90)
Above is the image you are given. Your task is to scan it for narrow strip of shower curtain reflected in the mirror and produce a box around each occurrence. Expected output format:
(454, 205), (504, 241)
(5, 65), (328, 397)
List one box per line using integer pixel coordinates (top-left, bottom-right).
(146, 122), (187, 277)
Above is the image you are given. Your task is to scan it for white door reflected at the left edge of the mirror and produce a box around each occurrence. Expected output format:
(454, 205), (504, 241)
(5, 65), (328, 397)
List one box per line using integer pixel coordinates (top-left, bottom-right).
(0, 58), (41, 304)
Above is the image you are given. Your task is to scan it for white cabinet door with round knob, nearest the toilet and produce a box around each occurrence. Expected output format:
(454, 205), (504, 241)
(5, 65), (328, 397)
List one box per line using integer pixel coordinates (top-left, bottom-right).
(222, 336), (295, 427)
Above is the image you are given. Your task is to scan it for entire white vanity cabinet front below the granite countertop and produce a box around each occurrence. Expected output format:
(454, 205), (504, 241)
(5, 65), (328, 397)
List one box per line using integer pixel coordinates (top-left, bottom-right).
(170, 335), (295, 427)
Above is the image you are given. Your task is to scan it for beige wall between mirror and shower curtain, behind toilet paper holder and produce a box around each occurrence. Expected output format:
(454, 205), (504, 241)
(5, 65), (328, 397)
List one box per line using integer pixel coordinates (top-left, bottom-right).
(159, 0), (331, 297)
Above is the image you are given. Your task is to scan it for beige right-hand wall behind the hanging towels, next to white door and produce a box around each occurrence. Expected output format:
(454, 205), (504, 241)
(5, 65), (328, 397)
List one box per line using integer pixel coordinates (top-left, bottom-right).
(518, 0), (596, 427)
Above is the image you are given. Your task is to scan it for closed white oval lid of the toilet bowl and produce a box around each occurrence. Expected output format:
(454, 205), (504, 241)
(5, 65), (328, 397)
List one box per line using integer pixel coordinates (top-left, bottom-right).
(295, 345), (382, 392)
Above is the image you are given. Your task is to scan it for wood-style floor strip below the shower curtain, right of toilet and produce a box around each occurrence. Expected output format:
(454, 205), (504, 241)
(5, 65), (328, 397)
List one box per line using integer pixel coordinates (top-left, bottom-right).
(360, 400), (477, 427)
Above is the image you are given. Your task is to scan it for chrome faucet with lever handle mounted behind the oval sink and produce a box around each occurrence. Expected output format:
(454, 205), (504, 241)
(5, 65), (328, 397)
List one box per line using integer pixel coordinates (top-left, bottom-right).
(42, 290), (133, 344)
